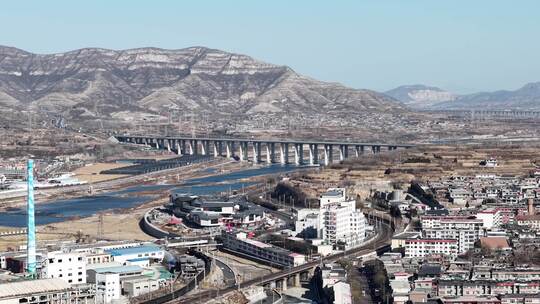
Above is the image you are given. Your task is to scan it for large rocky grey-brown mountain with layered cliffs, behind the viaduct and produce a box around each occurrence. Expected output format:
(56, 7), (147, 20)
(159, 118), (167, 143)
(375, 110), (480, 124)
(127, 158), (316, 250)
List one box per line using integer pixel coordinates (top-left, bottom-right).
(0, 46), (403, 119)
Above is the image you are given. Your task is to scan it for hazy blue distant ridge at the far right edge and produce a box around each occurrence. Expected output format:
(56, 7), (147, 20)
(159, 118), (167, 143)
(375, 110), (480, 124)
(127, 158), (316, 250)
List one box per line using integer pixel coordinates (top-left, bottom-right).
(432, 82), (540, 111)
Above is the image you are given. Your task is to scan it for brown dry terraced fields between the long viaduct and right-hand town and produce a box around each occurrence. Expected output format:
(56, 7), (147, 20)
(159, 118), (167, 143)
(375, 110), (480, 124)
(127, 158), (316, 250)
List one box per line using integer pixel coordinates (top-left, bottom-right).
(282, 143), (540, 202)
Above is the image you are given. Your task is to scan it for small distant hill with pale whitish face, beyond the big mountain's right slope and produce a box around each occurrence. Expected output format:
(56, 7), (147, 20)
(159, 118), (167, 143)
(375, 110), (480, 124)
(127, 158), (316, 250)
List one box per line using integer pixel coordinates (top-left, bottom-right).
(384, 84), (456, 108)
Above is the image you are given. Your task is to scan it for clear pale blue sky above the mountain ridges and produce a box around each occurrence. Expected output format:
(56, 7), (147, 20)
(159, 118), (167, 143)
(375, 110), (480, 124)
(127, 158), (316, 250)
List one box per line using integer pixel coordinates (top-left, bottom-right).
(0, 0), (540, 94)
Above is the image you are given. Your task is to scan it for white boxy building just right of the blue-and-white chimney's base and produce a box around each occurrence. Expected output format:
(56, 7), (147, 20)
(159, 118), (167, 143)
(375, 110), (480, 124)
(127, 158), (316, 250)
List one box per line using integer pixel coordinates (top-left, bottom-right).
(42, 251), (86, 285)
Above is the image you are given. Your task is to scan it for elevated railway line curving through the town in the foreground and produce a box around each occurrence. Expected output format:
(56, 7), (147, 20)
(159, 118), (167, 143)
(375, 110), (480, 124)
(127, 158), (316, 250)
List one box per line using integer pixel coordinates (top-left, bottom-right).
(170, 217), (393, 303)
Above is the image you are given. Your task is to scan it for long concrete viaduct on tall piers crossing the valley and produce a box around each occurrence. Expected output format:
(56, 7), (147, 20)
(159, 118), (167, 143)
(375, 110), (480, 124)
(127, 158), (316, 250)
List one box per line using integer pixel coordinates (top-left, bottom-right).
(115, 135), (413, 165)
